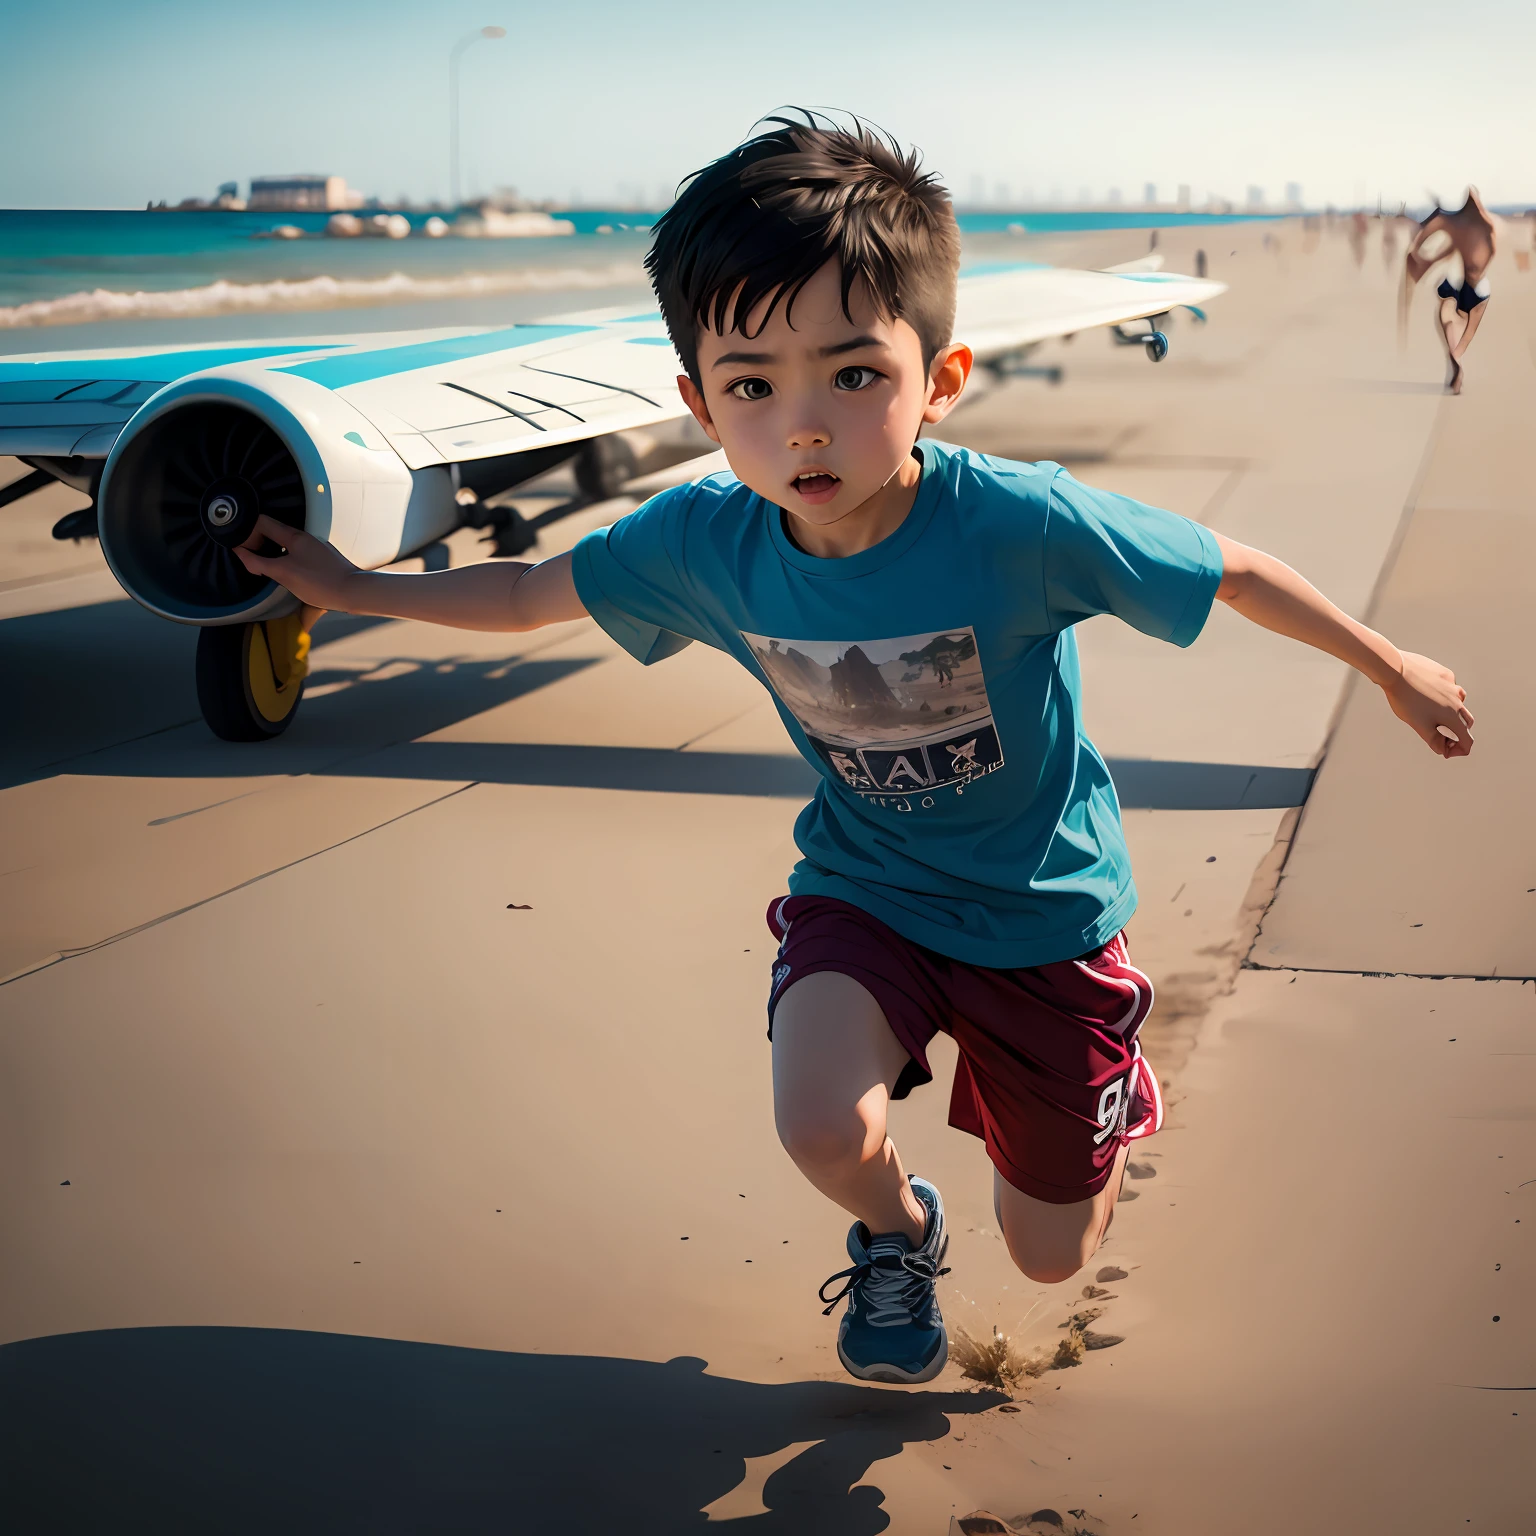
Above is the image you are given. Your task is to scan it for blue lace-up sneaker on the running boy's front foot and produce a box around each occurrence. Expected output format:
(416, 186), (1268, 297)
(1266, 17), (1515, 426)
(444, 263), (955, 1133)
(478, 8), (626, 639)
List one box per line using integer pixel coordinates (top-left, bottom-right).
(820, 1178), (949, 1384)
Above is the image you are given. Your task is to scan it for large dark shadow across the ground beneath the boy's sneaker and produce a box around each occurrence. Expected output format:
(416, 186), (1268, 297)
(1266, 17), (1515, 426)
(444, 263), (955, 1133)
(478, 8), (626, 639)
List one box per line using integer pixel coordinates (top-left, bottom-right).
(0, 1329), (1003, 1536)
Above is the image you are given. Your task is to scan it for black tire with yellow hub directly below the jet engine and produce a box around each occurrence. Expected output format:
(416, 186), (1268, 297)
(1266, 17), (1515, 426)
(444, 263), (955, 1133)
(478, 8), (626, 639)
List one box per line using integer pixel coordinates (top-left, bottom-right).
(197, 613), (309, 742)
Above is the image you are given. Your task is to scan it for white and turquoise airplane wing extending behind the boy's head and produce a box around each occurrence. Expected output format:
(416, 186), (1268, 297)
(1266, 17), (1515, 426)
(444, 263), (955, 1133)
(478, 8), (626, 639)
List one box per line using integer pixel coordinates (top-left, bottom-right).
(0, 261), (1224, 470)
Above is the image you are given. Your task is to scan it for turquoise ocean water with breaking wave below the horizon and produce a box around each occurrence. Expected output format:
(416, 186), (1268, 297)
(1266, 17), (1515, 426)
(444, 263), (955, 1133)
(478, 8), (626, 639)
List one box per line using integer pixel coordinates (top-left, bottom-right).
(0, 209), (1271, 352)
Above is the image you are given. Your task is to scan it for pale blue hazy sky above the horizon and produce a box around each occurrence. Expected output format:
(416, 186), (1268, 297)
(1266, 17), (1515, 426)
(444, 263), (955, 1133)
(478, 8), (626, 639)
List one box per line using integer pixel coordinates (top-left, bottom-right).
(0, 0), (1536, 207)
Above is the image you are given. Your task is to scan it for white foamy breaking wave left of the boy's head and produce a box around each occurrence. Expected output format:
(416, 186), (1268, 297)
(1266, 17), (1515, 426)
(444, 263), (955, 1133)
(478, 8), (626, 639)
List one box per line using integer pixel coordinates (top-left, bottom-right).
(0, 263), (645, 330)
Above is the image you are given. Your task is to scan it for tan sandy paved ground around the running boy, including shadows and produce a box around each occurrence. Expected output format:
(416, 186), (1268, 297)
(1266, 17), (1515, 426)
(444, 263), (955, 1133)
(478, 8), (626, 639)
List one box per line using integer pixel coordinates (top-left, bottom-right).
(0, 226), (1536, 1536)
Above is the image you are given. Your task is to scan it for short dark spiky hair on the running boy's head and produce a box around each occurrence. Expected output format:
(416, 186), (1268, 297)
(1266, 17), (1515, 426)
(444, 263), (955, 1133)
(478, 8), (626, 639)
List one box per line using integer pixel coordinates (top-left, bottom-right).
(645, 112), (960, 384)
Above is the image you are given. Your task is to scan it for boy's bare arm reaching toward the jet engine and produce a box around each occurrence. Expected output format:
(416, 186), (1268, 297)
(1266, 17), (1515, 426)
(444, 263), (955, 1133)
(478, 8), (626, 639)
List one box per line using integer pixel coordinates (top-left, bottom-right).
(235, 518), (587, 630)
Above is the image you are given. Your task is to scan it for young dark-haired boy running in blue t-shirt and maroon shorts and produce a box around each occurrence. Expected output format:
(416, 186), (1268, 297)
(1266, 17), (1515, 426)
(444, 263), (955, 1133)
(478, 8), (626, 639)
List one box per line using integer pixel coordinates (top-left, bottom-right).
(243, 120), (1473, 1382)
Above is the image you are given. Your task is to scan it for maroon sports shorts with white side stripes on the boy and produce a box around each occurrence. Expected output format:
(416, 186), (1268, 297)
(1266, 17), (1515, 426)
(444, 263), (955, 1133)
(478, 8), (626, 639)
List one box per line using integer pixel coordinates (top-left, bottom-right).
(768, 895), (1163, 1206)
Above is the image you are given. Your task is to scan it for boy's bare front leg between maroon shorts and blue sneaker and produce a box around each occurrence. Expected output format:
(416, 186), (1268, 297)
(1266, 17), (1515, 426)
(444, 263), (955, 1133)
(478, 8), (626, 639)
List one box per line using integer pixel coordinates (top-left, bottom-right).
(773, 971), (928, 1246)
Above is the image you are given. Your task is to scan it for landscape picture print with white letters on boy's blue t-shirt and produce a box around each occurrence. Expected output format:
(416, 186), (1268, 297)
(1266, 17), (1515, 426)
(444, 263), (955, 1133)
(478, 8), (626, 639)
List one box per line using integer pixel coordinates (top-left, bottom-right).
(742, 628), (1003, 794)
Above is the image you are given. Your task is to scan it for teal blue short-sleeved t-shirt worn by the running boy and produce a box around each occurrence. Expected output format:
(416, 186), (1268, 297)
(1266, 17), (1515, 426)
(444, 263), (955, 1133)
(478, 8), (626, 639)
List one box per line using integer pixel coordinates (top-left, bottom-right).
(573, 441), (1221, 968)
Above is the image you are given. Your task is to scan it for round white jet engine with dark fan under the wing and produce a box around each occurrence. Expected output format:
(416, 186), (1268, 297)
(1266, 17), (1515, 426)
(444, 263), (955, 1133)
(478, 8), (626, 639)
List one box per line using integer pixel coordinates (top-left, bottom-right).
(98, 370), (459, 625)
